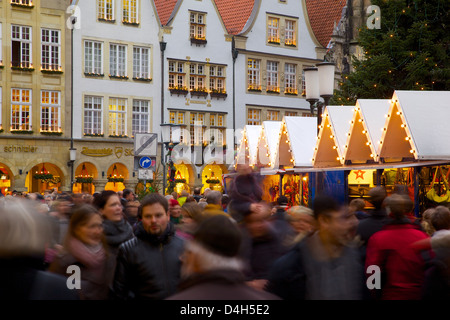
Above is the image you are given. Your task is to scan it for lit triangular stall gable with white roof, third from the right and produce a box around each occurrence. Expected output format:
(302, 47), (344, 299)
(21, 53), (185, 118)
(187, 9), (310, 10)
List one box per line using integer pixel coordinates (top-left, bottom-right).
(312, 106), (354, 167)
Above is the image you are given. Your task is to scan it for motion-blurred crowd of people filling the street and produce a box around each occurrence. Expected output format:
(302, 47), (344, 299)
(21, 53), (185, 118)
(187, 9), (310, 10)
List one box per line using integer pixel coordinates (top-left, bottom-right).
(0, 168), (450, 300)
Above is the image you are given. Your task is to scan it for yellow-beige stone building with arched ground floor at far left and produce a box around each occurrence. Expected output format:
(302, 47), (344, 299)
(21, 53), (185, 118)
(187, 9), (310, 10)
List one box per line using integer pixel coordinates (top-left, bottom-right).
(0, 0), (70, 194)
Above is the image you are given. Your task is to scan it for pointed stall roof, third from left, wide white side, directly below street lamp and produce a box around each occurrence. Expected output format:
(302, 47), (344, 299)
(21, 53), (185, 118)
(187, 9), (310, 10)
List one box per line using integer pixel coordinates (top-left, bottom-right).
(276, 117), (317, 167)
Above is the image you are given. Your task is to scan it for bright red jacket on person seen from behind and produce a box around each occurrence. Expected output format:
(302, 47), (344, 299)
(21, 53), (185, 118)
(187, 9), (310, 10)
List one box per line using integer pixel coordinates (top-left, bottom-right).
(366, 223), (428, 300)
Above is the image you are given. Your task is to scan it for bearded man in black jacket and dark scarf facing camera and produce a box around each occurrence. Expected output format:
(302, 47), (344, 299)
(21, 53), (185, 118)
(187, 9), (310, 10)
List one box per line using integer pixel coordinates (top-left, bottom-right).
(111, 193), (184, 300)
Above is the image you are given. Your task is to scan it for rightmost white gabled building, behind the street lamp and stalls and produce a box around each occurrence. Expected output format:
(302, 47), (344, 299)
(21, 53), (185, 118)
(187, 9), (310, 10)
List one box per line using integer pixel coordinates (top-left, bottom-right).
(227, 0), (324, 136)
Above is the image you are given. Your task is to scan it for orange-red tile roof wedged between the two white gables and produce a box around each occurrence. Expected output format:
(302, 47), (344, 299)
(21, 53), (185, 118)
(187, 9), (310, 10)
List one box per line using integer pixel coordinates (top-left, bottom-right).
(215, 0), (255, 34)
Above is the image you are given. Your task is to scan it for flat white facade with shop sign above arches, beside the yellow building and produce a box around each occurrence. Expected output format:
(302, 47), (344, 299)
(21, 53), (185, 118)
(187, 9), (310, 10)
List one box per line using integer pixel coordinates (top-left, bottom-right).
(72, 0), (160, 192)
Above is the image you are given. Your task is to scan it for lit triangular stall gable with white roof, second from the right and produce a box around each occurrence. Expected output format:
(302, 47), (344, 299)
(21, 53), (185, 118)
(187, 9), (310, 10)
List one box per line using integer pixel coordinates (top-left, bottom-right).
(344, 99), (390, 164)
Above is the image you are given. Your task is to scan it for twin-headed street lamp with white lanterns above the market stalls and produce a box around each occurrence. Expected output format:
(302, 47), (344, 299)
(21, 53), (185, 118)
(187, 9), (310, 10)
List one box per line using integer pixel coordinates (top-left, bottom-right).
(304, 62), (335, 127)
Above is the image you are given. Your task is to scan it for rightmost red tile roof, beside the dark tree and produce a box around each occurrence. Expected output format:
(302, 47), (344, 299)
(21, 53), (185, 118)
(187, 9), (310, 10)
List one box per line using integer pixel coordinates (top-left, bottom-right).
(306, 0), (347, 47)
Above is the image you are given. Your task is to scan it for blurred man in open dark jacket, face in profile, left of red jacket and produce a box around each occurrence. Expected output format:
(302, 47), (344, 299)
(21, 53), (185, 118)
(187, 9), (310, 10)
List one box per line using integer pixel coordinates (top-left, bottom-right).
(266, 195), (366, 300)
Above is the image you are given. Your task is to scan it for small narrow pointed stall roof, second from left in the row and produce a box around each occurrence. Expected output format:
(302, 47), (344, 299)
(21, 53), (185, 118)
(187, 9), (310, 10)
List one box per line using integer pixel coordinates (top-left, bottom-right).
(256, 121), (281, 168)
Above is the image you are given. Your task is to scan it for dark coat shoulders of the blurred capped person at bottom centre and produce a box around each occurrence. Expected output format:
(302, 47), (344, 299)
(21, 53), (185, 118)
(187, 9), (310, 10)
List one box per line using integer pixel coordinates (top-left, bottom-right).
(167, 270), (280, 300)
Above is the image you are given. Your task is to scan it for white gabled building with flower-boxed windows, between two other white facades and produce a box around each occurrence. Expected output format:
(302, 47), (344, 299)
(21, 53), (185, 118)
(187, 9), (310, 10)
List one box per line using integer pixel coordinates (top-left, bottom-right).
(155, 0), (234, 192)
